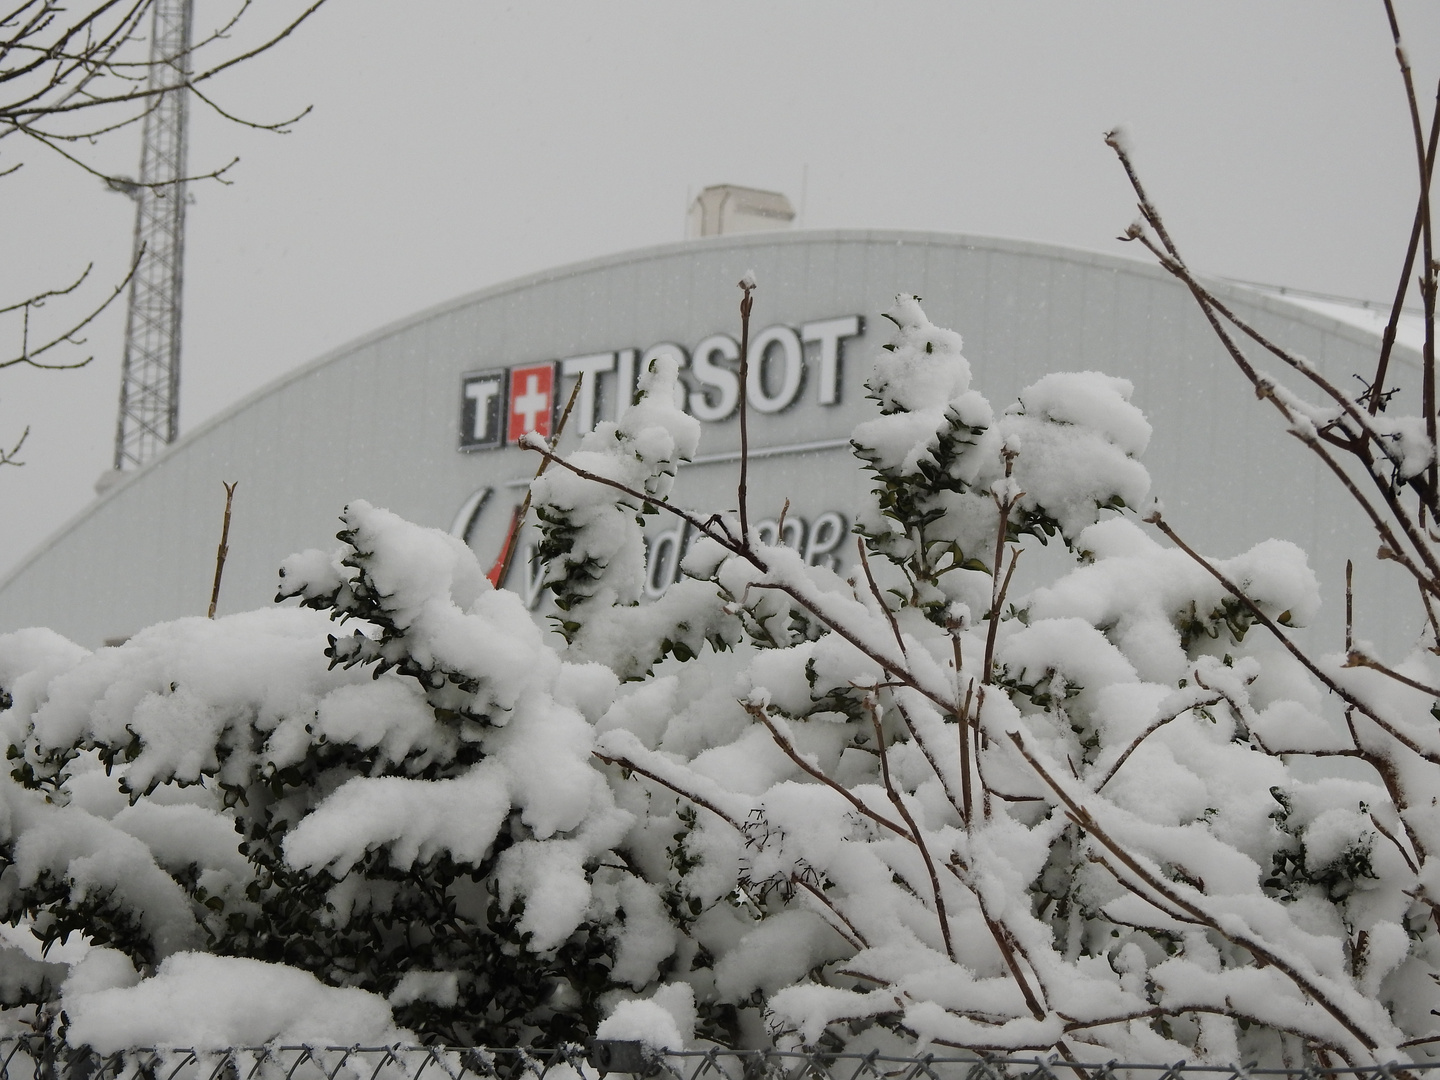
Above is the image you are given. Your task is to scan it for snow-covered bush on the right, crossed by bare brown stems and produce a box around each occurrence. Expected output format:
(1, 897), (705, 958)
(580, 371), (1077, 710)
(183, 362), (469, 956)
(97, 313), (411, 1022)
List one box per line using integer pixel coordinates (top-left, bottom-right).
(567, 298), (1436, 1061)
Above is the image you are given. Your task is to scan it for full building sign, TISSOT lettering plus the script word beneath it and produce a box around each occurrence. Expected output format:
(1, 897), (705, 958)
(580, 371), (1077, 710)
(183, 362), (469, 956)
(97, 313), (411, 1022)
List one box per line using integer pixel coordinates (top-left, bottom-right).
(451, 315), (864, 608)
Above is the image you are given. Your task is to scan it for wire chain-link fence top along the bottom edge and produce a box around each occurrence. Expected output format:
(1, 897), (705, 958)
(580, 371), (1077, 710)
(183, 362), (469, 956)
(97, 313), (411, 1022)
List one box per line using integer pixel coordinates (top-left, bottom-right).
(0, 1037), (1440, 1080)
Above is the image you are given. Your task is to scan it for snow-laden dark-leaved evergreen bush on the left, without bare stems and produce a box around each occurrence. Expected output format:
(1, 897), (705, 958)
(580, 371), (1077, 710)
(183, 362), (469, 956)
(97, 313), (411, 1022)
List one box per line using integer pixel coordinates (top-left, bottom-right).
(0, 515), (645, 1043)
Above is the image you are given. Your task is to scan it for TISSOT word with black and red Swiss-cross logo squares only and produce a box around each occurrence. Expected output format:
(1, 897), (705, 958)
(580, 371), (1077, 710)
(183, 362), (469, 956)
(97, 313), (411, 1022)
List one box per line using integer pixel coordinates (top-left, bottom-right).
(459, 315), (864, 451)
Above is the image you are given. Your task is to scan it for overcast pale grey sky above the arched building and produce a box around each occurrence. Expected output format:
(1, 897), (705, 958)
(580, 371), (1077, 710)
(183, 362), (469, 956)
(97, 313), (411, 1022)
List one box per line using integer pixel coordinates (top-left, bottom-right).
(0, 0), (1440, 575)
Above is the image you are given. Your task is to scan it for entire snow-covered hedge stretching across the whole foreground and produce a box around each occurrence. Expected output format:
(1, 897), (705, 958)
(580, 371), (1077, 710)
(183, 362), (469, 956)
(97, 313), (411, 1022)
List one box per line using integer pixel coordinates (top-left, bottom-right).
(0, 297), (1440, 1063)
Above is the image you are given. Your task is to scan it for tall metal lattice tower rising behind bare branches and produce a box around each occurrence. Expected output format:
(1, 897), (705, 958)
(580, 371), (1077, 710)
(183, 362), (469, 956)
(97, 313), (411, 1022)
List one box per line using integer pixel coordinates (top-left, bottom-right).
(115, 0), (193, 469)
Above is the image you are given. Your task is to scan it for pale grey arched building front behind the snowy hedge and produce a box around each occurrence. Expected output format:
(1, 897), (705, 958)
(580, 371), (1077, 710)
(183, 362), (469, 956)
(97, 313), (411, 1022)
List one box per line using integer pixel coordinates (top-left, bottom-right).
(0, 230), (1418, 647)
